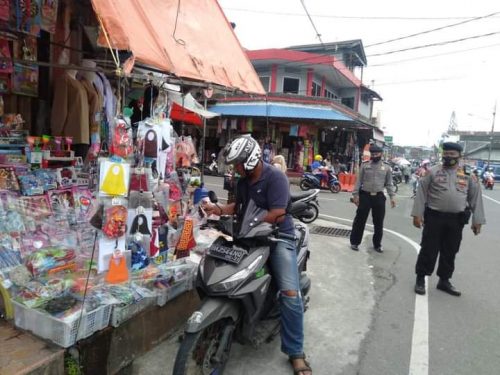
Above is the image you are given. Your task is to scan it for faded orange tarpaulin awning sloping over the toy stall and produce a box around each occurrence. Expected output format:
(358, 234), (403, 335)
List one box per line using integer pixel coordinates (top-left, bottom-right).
(92, 0), (265, 94)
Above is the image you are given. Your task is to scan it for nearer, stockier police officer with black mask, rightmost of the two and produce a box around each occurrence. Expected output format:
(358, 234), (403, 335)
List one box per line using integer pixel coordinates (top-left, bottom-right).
(411, 142), (486, 297)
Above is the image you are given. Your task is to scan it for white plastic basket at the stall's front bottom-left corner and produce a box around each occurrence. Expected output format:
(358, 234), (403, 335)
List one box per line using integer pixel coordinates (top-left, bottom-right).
(12, 301), (112, 348)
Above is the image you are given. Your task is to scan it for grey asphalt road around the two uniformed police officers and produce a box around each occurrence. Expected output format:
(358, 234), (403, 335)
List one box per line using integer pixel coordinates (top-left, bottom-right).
(201, 177), (500, 375)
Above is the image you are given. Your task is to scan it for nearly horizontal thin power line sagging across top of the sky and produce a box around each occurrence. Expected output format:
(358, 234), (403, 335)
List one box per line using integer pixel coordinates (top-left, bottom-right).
(224, 7), (496, 21)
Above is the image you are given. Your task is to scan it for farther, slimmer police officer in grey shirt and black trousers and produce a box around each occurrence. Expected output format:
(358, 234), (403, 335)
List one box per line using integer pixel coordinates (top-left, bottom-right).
(351, 145), (396, 253)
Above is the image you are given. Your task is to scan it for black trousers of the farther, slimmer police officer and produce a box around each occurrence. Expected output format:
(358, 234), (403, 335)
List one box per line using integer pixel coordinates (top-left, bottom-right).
(351, 191), (386, 247)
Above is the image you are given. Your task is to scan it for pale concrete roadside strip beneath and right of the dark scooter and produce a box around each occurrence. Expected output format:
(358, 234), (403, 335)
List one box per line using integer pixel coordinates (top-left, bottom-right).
(132, 220), (375, 375)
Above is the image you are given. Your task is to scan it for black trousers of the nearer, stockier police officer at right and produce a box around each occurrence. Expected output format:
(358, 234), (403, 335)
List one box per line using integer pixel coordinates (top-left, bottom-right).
(415, 209), (464, 279)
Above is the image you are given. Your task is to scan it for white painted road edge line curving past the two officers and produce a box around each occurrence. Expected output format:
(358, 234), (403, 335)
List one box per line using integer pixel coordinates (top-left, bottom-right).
(319, 216), (428, 375)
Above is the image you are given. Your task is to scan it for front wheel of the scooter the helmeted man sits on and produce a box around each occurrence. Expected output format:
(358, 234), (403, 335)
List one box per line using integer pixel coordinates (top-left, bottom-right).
(172, 319), (232, 375)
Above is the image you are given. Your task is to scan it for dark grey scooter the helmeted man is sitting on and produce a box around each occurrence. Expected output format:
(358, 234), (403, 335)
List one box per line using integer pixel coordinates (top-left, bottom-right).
(173, 192), (311, 375)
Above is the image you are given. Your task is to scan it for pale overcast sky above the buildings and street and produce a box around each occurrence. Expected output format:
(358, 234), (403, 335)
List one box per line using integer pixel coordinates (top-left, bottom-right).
(219, 0), (500, 146)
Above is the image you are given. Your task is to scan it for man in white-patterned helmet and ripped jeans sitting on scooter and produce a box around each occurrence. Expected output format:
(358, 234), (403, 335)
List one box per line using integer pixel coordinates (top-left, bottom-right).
(203, 135), (312, 375)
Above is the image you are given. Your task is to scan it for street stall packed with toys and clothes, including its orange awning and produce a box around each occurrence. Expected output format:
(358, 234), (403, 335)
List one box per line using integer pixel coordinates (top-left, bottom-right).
(0, 0), (263, 374)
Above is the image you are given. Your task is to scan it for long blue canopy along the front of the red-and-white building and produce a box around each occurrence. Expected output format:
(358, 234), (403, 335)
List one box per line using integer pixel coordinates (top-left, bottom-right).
(209, 103), (354, 121)
